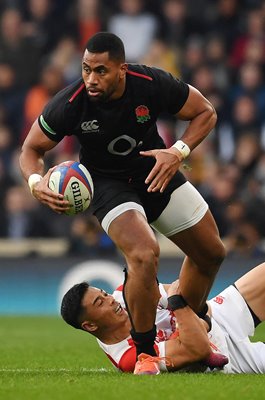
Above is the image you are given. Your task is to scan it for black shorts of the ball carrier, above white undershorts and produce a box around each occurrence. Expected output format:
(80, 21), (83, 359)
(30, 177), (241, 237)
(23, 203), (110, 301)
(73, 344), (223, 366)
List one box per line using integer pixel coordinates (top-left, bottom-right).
(91, 172), (186, 223)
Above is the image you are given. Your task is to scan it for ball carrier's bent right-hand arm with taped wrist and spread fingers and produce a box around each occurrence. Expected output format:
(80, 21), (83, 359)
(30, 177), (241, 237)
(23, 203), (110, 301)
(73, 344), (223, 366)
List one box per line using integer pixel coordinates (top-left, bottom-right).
(140, 85), (217, 192)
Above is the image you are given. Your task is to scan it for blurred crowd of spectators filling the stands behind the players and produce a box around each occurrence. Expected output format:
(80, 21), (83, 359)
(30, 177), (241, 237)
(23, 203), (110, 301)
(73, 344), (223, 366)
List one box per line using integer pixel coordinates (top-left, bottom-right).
(0, 0), (265, 256)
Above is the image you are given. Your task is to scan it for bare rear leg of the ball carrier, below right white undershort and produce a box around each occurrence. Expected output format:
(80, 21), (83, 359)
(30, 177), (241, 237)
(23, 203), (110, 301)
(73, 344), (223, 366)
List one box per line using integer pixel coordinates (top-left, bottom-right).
(169, 211), (225, 312)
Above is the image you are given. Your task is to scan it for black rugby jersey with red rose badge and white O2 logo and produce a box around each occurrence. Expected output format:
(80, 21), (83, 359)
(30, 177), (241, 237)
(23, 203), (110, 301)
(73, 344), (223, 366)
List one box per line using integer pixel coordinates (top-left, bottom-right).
(39, 64), (189, 178)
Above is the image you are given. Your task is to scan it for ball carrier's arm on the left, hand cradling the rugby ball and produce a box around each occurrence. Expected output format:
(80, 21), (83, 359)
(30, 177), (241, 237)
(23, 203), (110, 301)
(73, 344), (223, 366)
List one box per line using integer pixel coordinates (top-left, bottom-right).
(19, 120), (69, 213)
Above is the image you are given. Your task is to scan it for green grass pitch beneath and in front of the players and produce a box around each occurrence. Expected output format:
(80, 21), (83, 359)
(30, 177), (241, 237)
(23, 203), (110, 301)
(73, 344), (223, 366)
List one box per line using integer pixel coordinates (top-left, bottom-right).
(0, 317), (265, 400)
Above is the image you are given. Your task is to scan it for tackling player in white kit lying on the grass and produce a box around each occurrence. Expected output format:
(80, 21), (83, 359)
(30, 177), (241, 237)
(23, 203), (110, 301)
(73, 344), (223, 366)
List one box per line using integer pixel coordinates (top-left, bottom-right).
(61, 263), (265, 374)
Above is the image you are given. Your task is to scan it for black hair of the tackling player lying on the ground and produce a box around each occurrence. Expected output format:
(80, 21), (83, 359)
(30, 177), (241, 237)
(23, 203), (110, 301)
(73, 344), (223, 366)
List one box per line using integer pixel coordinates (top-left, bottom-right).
(61, 282), (89, 329)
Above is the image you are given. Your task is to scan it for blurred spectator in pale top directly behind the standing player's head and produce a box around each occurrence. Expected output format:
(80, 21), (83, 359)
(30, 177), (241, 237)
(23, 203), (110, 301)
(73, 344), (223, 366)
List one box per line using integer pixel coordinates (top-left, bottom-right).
(107, 0), (159, 62)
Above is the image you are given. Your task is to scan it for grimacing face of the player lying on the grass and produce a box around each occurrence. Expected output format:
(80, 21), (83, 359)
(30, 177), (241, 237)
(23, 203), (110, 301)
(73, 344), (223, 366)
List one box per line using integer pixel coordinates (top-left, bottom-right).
(82, 287), (128, 329)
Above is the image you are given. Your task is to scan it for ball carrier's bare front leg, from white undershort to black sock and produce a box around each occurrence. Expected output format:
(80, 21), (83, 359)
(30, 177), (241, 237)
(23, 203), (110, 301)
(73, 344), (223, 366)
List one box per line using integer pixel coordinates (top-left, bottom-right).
(109, 210), (159, 332)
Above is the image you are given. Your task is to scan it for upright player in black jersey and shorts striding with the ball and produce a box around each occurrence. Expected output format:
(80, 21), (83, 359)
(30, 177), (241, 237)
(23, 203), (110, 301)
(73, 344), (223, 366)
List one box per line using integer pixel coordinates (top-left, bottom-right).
(20, 32), (225, 374)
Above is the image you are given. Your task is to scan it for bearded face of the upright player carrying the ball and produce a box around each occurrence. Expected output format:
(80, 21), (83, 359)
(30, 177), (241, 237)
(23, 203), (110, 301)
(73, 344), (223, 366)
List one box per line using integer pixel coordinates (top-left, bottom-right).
(82, 50), (127, 102)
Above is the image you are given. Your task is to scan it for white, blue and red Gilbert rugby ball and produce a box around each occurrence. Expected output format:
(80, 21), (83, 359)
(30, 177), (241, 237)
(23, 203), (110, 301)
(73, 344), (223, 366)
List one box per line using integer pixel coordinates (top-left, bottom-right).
(49, 161), (94, 215)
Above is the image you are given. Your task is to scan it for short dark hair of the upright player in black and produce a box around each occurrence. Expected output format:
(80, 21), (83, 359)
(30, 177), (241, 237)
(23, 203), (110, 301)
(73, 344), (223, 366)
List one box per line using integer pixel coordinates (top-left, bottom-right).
(86, 32), (125, 62)
